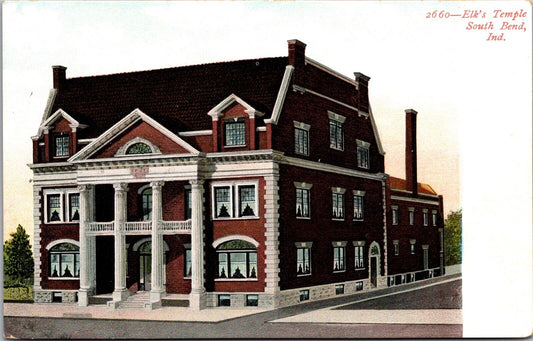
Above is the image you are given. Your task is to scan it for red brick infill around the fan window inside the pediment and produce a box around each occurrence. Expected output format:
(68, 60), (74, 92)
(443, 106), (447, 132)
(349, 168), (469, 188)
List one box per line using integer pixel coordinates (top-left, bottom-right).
(94, 121), (189, 158)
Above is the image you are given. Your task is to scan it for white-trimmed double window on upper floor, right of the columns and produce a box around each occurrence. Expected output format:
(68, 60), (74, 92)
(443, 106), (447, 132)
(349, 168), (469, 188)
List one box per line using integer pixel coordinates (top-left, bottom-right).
(213, 183), (258, 218)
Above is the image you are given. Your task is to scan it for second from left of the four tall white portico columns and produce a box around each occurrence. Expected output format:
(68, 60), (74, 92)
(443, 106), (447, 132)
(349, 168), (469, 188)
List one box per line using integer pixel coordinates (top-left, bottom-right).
(113, 183), (128, 302)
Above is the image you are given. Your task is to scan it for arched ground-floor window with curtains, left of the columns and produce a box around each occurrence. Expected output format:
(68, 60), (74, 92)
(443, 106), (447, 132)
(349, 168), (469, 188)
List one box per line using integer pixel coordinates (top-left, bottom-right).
(49, 243), (80, 278)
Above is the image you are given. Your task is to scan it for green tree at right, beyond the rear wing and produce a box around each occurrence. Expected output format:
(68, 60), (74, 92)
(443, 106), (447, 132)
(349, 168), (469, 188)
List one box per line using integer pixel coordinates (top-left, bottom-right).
(444, 209), (463, 265)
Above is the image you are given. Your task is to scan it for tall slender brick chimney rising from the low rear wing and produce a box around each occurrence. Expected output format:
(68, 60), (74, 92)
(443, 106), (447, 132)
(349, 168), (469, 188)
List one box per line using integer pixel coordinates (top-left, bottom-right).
(405, 109), (418, 196)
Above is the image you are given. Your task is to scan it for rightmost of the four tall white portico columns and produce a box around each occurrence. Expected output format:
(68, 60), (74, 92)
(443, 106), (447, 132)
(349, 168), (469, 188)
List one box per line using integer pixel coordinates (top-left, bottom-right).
(189, 179), (205, 310)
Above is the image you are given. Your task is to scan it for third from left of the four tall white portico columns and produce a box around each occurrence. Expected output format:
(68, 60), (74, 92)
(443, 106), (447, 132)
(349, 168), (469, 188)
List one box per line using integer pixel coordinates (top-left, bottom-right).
(150, 181), (165, 308)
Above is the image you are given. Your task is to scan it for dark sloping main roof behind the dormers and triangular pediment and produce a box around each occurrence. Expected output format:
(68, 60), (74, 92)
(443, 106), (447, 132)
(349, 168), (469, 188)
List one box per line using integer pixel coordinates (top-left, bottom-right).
(52, 57), (288, 138)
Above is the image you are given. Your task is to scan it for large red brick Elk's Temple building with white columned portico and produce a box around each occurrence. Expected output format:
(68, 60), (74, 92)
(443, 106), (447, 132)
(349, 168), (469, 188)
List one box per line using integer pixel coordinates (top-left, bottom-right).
(30, 40), (442, 309)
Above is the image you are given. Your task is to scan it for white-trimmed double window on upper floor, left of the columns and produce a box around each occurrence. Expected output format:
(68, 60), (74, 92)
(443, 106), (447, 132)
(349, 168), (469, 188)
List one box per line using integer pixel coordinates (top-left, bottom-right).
(43, 188), (80, 223)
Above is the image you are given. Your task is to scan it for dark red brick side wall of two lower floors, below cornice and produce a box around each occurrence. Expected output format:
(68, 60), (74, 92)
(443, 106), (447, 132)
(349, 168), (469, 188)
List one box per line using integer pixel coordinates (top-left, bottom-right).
(279, 165), (384, 290)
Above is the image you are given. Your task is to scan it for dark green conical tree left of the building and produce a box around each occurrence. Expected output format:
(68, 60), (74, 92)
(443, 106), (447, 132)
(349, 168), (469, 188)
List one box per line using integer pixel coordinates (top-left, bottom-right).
(4, 224), (33, 286)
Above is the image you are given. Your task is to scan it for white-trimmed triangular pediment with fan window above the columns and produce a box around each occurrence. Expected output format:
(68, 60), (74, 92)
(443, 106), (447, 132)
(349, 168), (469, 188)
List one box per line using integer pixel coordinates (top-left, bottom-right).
(69, 109), (199, 162)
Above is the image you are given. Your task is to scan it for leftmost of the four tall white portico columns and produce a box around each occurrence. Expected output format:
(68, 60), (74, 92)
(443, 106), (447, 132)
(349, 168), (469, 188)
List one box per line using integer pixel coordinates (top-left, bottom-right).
(78, 185), (92, 307)
